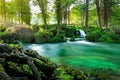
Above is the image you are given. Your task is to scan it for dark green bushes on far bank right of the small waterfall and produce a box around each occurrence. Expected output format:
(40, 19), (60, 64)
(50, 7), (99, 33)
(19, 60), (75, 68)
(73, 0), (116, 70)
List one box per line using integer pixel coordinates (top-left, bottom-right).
(86, 28), (120, 43)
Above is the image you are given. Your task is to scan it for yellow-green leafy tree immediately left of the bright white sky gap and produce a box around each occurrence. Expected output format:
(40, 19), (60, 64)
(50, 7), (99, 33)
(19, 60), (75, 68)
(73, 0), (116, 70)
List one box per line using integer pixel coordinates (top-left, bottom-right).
(14, 0), (31, 24)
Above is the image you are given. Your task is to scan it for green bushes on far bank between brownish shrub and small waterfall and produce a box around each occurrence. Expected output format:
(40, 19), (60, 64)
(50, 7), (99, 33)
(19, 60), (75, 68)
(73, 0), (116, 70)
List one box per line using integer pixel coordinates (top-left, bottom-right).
(35, 28), (65, 43)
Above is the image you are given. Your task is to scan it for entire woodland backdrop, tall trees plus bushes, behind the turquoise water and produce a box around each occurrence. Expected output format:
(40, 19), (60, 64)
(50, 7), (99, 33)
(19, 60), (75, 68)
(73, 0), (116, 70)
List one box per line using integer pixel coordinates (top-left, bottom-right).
(0, 0), (120, 43)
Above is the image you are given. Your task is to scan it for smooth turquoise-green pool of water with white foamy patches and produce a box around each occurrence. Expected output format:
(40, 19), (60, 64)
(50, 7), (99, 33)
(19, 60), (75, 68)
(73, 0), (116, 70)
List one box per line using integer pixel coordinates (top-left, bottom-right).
(25, 41), (120, 72)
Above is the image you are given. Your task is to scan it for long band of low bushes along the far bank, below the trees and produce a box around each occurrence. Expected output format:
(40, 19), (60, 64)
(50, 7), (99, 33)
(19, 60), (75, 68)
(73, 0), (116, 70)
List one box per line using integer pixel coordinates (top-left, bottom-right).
(0, 25), (120, 44)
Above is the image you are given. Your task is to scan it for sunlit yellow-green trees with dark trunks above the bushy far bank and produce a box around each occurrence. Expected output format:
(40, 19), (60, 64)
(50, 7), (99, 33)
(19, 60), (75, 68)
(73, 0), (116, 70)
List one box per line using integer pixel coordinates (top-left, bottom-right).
(0, 0), (120, 27)
